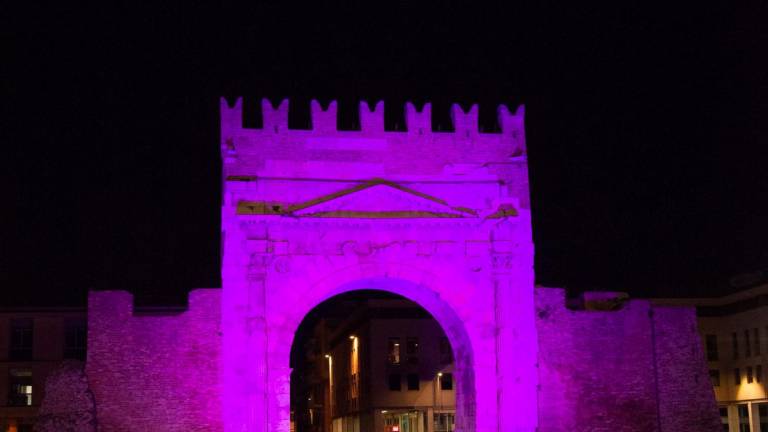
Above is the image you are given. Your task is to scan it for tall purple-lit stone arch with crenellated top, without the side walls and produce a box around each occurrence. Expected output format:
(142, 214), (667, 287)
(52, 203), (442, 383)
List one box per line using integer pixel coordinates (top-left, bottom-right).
(221, 100), (537, 432)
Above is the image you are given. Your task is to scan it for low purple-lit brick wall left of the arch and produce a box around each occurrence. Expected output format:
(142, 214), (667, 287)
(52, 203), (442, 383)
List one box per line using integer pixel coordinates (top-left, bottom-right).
(86, 290), (222, 432)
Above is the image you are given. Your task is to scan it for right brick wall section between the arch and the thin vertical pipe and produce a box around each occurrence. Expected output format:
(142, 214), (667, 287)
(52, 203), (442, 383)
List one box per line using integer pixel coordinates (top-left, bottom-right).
(535, 288), (657, 432)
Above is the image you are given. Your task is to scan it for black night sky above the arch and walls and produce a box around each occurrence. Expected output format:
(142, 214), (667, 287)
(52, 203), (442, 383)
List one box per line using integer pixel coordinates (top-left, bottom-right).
(0, 1), (768, 304)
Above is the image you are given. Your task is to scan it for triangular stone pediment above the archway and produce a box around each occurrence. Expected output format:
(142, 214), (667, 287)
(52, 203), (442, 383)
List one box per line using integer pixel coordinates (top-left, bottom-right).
(239, 180), (477, 218)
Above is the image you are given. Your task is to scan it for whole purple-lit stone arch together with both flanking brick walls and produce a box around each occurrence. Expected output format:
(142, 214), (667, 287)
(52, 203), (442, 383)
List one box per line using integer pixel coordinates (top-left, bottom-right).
(87, 100), (717, 432)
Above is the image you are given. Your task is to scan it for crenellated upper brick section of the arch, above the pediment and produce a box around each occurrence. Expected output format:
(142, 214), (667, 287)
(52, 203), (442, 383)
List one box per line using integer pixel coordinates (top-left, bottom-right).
(221, 98), (527, 187)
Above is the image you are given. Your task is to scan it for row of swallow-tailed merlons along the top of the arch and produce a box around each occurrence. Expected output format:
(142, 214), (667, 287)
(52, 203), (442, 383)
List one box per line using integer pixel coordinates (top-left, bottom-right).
(221, 98), (525, 137)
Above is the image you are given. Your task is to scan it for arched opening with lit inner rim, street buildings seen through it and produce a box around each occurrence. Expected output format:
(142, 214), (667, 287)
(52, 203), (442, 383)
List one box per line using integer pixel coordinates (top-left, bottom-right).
(290, 279), (475, 432)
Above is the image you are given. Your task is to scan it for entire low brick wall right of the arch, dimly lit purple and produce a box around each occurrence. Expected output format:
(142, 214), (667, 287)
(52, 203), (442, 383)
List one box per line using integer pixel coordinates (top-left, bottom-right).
(535, 288), (718, 432)
